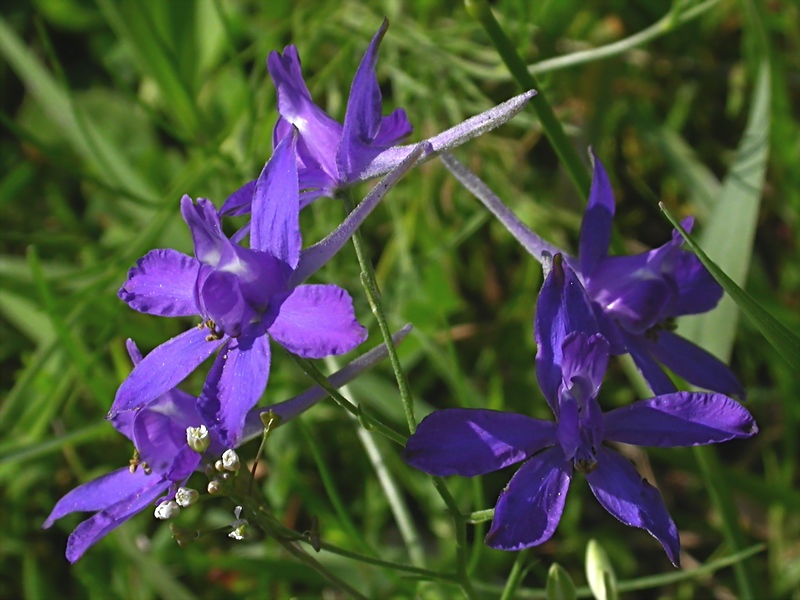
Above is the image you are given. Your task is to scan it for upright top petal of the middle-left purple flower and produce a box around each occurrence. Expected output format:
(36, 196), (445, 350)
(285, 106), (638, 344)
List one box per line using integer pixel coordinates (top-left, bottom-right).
(250, 133), (302, 268)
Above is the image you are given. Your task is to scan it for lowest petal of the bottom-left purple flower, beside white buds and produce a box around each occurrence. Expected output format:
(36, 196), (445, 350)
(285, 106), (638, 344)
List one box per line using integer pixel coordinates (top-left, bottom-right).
(66, 470), (172, 563)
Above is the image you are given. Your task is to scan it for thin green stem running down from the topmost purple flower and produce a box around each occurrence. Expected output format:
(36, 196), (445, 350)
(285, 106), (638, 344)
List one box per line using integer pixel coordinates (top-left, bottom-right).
(337, 190), (417, 433)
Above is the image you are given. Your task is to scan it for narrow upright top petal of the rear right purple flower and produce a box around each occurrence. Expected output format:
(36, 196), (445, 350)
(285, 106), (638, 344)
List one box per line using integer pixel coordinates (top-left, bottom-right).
(578, 154), (615, 279)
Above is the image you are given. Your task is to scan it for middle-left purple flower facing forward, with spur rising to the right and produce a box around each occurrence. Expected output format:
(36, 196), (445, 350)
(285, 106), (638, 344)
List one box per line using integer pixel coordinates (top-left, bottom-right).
(114, 135), (424, 447)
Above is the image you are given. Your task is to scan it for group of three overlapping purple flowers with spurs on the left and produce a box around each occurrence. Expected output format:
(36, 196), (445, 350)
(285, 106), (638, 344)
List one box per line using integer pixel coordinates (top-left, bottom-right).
(44, 21), (535, 561)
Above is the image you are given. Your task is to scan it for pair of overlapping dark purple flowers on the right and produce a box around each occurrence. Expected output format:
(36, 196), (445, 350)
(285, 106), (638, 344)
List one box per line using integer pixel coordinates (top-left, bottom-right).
(404, 156), (758, 566)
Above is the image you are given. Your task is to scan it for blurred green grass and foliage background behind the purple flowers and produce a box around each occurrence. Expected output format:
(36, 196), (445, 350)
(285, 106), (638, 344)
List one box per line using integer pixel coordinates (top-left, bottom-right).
(0, 0), (800, 600)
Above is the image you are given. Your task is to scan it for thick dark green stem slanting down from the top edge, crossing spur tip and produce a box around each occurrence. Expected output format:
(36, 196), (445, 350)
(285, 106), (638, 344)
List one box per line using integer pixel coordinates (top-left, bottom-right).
(464, 0), (592, 200)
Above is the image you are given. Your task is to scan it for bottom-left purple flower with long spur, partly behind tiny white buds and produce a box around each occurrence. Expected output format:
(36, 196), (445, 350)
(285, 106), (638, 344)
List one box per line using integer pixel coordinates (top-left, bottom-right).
(43, 325), (411, 562)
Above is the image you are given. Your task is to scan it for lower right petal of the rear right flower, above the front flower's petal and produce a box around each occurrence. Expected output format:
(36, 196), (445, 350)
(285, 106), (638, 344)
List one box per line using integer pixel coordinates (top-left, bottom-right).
(647, 331), (747, 398)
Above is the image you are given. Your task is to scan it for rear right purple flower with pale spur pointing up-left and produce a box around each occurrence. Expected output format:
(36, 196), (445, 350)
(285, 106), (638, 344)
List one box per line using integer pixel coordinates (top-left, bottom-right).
(442, 154), (745, 398)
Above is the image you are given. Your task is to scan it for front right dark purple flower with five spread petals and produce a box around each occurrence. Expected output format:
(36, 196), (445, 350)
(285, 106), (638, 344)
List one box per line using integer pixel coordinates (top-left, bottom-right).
(404, 256), (757, 566)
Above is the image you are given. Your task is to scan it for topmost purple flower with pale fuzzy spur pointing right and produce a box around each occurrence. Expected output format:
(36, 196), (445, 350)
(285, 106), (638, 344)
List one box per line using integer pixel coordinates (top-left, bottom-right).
(220, 19), (536, 215)
